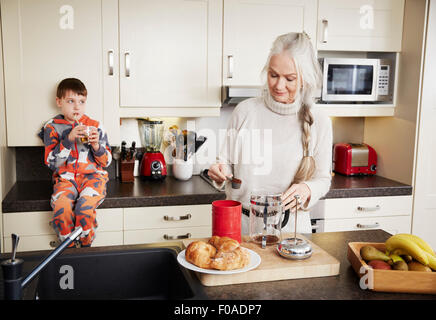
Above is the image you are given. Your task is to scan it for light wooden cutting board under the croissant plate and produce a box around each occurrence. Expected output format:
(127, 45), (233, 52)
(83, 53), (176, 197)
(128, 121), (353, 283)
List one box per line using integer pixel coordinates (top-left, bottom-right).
(183, 235), (340, 286)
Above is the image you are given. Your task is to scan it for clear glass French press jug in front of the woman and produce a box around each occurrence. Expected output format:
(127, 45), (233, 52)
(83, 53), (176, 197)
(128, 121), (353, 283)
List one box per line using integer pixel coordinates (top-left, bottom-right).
(249, 194), (287, 248)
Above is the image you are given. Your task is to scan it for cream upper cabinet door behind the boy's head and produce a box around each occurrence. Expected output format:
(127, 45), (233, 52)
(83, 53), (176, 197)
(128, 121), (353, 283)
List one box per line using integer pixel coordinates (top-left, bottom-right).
(1, 0), (103, 146)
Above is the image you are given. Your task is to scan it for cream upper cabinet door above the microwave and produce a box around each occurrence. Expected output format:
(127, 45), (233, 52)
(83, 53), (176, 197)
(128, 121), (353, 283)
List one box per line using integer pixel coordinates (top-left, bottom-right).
(317, 0), (404, 51)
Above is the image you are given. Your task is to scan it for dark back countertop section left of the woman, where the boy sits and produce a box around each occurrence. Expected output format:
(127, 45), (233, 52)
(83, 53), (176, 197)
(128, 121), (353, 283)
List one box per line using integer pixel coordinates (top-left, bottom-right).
(2, 176), (225, 213)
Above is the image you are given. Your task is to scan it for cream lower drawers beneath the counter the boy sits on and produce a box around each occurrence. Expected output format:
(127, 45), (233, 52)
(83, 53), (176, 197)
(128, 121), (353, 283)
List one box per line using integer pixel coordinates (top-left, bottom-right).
(2, 204), (212, 252)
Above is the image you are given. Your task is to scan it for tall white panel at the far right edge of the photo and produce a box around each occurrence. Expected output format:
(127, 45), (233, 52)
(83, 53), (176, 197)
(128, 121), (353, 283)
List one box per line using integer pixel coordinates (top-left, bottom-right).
(412, 0), (436, 248)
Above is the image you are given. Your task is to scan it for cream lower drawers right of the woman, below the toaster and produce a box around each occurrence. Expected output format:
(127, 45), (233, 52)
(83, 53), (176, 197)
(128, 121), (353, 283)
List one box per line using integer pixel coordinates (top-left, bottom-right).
(311, 196), (412, 234)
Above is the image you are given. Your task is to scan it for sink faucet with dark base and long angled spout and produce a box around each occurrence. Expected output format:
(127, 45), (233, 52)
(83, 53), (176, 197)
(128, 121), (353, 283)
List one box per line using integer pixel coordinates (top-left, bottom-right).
(1, 227), (83, 300)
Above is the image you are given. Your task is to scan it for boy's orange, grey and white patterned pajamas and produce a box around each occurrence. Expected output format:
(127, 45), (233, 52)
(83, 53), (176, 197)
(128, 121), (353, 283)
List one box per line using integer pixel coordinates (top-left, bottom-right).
(44, 115), (112, 246)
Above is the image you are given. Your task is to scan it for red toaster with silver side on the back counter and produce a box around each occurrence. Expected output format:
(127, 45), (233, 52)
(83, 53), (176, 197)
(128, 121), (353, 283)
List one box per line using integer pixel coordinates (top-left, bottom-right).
(333, 143), (377, 176)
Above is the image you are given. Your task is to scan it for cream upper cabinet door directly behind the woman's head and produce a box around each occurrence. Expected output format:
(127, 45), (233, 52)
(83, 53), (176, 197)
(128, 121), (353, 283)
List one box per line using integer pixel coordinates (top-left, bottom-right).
(223, 0), (317, 86)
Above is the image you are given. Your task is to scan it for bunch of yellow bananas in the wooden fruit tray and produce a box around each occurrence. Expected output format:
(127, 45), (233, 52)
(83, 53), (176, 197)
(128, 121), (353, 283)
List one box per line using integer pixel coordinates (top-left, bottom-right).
(385, 233), (436, 270)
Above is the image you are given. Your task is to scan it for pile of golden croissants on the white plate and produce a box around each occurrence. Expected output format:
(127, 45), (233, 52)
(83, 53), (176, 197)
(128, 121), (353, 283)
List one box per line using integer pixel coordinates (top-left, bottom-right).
(185, 236), (250, 270)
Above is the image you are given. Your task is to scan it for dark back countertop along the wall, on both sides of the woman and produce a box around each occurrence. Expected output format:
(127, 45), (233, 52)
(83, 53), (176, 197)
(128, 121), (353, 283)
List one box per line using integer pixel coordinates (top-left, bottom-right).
(2, 174), (412, 213)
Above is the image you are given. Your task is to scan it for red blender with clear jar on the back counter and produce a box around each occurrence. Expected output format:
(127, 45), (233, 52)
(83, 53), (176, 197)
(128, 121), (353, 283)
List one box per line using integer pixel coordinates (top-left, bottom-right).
(138, 118), (167, 180)
